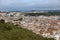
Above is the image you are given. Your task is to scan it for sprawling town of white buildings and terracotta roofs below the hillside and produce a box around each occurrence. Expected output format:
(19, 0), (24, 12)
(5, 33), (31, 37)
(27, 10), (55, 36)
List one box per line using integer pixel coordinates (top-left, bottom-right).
(0, 12), (60, 40)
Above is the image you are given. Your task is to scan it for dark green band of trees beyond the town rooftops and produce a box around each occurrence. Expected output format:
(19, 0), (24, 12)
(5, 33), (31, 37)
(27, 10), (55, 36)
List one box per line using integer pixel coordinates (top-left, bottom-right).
(25, 12), (60, 16)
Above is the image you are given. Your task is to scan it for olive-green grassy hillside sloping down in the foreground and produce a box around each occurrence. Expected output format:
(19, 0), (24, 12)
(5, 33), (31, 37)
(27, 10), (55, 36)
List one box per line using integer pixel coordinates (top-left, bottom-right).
(0, 20), (54, 40)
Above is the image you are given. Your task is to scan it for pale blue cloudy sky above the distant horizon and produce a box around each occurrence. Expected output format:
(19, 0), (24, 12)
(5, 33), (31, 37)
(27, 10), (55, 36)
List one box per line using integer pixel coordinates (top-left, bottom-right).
(0, 0), (60, 10)
